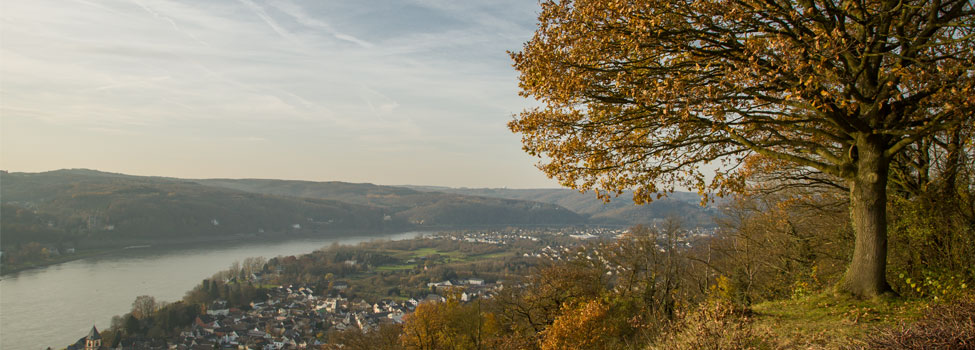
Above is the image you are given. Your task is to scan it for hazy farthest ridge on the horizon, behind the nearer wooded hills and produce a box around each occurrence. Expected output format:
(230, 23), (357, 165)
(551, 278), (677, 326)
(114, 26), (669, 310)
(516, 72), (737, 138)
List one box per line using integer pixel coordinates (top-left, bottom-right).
(195, 179), (715, 226)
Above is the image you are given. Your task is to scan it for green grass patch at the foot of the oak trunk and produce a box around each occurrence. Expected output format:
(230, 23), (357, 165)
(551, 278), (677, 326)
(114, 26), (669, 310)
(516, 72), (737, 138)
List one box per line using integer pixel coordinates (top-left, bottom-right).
(751, 292), (927, 349)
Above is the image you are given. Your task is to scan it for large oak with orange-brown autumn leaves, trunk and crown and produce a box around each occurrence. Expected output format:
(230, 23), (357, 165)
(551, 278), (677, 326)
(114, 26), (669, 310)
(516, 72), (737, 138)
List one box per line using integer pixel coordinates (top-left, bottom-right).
(509, 0), (975, 296)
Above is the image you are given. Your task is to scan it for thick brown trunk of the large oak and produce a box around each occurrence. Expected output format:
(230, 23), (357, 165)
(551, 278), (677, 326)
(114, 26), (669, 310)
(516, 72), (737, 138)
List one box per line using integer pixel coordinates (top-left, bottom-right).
(839, 135), (891, 297)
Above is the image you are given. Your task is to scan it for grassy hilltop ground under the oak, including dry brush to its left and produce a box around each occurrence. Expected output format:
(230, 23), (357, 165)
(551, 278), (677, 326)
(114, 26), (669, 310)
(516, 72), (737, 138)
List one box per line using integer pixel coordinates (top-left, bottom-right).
(650, 293), (936, 350)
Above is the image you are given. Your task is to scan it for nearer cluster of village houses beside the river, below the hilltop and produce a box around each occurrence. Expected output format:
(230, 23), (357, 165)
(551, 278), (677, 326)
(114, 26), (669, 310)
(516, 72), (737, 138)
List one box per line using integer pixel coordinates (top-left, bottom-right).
(67, 279), (503, 350)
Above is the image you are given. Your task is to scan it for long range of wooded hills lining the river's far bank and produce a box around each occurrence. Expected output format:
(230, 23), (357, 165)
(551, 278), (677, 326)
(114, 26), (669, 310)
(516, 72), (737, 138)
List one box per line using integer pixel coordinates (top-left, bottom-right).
(0, 169), (586, 247)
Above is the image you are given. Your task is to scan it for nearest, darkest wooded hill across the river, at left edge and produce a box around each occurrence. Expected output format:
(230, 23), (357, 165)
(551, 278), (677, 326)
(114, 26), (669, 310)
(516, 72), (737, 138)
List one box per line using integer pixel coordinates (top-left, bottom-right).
(2, 170), (396, 246)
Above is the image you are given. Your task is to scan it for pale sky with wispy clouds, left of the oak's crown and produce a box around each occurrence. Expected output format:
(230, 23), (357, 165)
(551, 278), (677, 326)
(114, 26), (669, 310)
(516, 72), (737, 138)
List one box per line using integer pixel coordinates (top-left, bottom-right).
(0, 0), (558, 188)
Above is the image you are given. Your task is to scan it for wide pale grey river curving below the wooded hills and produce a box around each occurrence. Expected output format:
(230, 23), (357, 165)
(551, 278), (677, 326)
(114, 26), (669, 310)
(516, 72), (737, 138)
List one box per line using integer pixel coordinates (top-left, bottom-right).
(0, 232), (422, 350)
